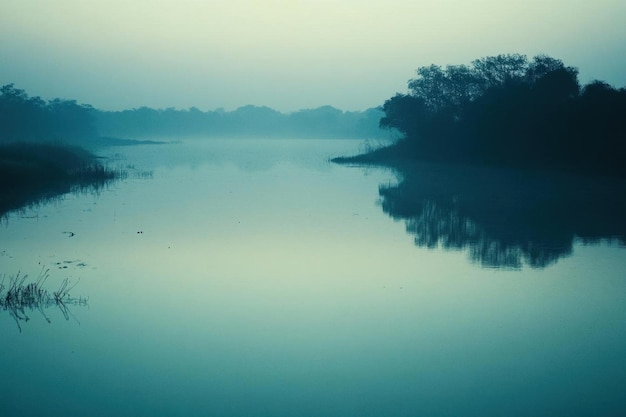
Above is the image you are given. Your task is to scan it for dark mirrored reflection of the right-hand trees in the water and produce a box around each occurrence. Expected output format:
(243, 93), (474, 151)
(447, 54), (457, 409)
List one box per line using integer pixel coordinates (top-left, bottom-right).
(379, 164), (626, 268)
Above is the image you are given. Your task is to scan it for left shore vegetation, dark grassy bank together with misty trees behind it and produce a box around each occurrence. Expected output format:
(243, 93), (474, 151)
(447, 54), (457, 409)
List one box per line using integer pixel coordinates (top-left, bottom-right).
(0, 84), (116, 217)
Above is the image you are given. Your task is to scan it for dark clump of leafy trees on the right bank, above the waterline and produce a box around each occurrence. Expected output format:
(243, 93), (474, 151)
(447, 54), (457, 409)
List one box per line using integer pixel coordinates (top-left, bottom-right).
(379, 54), (626, 176)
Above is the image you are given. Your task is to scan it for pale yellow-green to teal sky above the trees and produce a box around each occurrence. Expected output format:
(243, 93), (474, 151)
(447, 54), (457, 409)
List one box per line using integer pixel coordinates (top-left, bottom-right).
(0, 0), (626, 112)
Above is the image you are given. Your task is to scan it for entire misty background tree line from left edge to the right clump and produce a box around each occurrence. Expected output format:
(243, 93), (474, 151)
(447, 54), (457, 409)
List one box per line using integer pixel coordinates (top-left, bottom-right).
(0, 84), (390, 144)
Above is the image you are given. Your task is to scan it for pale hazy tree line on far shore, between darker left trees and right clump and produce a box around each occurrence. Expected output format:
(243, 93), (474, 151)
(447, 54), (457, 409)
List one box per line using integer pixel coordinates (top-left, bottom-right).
(97, 105), (389, 139)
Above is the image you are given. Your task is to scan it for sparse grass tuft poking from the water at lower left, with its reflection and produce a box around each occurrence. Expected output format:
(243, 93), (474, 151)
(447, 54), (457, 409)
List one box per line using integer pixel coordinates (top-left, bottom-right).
(0, 270), (87, 333)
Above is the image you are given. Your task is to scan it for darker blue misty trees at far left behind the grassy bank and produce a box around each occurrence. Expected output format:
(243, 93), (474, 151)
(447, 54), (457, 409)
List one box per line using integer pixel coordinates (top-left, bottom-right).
(0, 84), (98, 143)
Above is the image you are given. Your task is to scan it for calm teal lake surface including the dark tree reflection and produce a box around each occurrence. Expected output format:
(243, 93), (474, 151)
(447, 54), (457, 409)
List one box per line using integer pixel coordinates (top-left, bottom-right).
(0, 139), (626, 417)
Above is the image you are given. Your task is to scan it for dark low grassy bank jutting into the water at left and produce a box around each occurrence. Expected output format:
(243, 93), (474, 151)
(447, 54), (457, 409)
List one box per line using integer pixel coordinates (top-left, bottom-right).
(0, 142), (115, 216)
